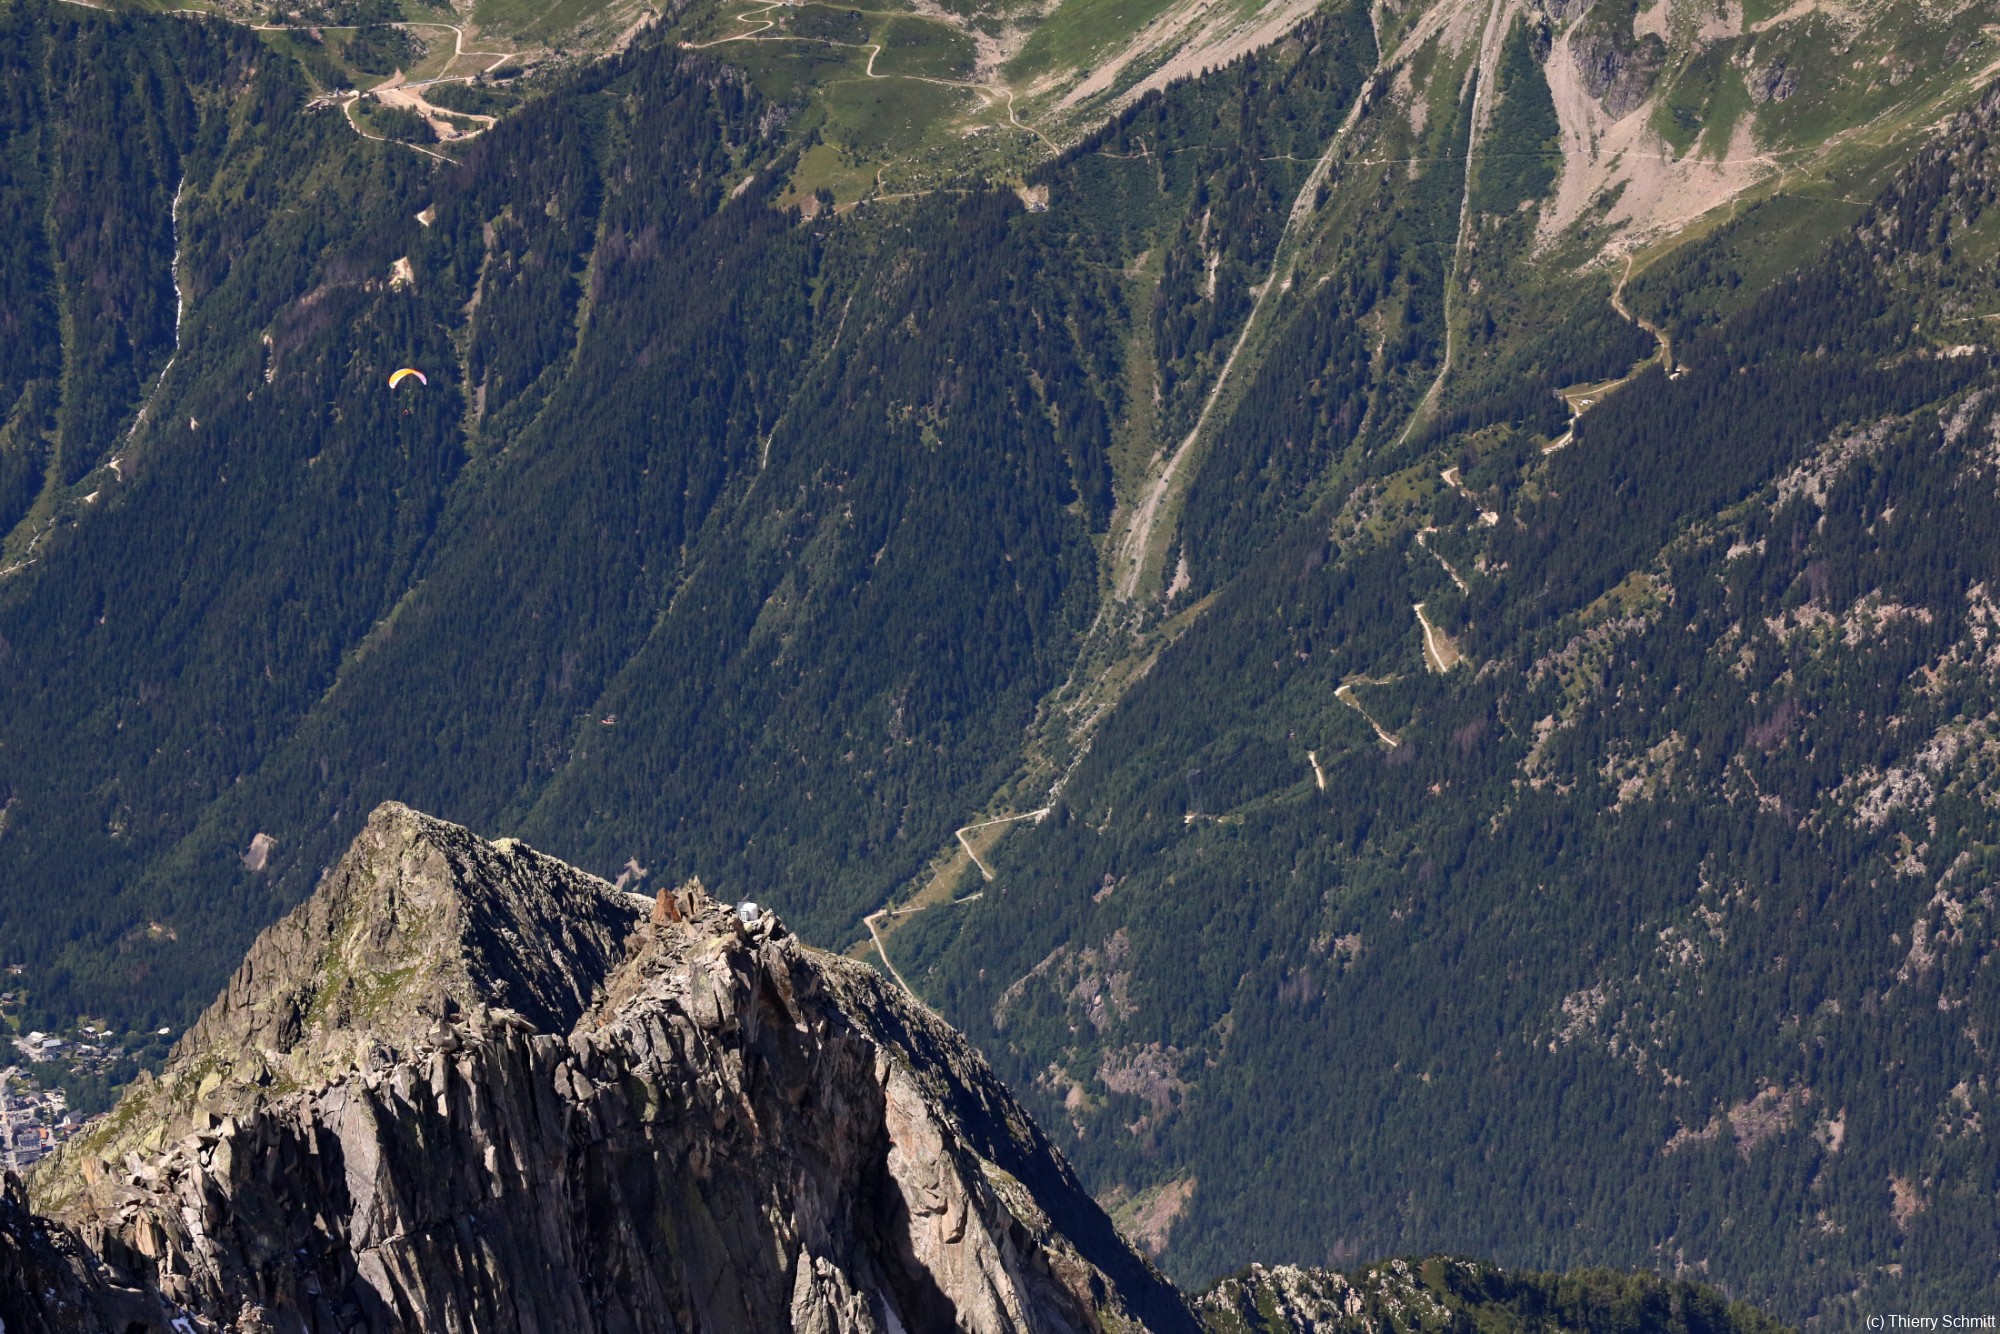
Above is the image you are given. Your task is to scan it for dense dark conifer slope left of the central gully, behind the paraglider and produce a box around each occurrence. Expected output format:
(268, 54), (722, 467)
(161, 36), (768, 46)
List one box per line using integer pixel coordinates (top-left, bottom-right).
(0, 6), (1124, 1022)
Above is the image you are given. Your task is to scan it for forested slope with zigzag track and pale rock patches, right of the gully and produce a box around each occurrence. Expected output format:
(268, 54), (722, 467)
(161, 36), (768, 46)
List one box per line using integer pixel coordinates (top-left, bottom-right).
(898, 81), (2000, 1318)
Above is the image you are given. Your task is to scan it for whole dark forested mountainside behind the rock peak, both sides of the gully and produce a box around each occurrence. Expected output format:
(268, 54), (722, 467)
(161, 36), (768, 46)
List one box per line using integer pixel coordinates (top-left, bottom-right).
(0, 0), (2000, 1332)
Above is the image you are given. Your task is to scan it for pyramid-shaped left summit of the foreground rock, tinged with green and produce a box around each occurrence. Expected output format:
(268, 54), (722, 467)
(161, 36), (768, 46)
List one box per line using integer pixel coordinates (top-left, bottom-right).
(42, 802), (646, 1202)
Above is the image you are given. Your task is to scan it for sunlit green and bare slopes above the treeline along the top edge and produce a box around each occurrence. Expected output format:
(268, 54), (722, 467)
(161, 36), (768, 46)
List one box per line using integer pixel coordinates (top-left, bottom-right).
(90, 0), (2000, 226)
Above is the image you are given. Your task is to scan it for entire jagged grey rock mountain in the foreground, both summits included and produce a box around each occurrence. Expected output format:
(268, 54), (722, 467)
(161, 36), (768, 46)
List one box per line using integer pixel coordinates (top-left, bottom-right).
(23, 806), (1196, 1334)
